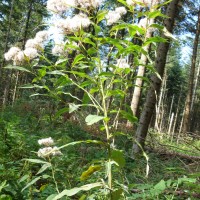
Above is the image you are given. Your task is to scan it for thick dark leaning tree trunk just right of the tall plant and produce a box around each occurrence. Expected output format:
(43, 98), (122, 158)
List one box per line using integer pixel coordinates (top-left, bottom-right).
(132, 0), (179, 156)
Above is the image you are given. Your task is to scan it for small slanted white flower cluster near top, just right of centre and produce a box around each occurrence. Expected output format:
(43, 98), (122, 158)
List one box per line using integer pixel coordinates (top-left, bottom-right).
(105, 6), (127, 26)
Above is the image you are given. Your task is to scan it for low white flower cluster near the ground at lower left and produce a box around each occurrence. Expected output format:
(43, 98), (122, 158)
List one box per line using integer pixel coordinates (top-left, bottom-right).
(37, 137), (62, 158)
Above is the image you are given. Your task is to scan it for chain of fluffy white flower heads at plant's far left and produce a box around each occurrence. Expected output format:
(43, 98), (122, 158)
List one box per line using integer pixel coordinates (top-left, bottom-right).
(4, 31), (48, 65)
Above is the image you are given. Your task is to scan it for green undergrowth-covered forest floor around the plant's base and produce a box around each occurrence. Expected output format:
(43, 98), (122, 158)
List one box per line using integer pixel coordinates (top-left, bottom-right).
(0, 102), (200, 200)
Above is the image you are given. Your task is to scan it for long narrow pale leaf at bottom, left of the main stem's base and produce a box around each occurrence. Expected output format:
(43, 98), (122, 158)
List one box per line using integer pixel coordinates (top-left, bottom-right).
(53, 182), (103, 200)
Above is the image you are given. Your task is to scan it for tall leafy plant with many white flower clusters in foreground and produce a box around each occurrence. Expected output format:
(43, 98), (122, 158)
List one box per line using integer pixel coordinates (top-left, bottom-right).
(5, 0), (170, 199)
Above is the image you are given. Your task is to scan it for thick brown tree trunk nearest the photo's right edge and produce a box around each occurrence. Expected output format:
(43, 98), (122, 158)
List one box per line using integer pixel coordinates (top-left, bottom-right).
(183, 10), (200, 133)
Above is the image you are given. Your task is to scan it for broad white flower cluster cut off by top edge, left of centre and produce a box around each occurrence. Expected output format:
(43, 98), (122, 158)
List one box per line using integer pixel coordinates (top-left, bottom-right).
(47, 0), (103, 13)
